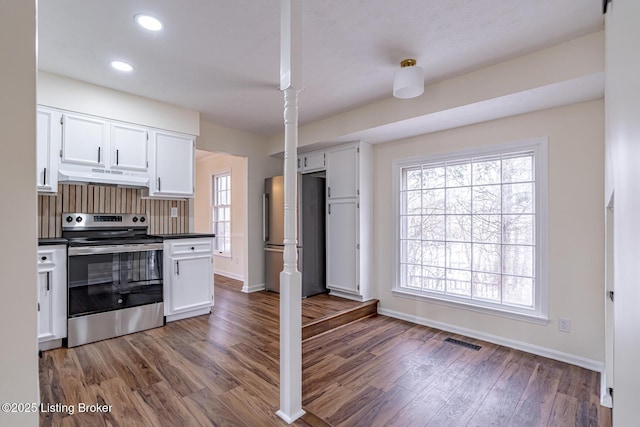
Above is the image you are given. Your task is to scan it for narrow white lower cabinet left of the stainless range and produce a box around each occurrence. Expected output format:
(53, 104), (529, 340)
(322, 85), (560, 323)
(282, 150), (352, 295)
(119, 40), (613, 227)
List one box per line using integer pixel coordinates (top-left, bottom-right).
(38, 245), (67, 350)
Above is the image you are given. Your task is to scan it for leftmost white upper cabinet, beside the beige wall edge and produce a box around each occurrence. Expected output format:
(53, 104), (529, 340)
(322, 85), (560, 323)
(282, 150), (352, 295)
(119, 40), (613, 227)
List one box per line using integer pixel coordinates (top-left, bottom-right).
(36, 107), (62, 193)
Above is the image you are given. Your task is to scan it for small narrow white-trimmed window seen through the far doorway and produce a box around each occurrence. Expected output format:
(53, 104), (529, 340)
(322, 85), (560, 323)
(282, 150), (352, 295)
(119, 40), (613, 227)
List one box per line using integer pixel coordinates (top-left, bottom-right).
(211, 173), (231, 256)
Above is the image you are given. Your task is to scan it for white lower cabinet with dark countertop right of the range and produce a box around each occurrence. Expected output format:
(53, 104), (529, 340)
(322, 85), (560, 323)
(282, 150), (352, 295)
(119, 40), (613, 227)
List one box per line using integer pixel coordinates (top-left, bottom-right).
(163, 237), (213, 322)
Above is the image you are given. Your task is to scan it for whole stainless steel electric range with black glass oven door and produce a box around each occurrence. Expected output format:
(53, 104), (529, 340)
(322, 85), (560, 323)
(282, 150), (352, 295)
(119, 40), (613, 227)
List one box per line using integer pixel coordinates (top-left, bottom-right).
(62, 213), (164, 347)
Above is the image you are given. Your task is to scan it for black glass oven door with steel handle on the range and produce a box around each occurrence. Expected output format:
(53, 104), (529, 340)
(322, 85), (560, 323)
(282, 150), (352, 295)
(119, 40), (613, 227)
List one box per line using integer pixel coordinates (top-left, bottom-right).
(68, 243), (162, 317)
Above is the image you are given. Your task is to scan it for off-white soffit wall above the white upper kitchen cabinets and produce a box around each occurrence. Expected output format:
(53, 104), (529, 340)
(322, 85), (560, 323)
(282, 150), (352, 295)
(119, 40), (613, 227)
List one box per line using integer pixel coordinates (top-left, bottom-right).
(38, 70), (200, 135)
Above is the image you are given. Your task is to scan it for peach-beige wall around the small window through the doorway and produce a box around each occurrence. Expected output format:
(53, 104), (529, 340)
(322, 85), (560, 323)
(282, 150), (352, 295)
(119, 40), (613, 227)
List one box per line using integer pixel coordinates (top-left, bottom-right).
(193, 154), (247, 280)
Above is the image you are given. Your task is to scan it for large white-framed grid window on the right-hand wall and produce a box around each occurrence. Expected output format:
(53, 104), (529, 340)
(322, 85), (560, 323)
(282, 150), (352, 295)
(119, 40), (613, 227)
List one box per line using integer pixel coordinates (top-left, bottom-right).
(396, 140), (546, 317)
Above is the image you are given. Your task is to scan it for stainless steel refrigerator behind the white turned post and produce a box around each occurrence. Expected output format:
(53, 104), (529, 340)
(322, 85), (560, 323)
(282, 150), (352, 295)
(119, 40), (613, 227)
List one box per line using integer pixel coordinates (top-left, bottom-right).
(263, 174), (327, 298)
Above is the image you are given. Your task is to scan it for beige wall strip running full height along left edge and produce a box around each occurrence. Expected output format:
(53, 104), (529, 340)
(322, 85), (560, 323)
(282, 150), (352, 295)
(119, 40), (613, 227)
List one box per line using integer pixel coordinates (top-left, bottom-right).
(0, 0), (40, 426)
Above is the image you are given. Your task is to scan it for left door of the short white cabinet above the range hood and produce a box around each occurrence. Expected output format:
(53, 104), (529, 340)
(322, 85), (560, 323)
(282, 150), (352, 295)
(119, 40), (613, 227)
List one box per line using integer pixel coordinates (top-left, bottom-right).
(61, 113), (109, 167)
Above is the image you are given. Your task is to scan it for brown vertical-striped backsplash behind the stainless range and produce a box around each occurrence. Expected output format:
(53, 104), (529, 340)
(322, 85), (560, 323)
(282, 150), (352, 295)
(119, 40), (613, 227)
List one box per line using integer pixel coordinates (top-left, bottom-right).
(38, 184), (189, 238)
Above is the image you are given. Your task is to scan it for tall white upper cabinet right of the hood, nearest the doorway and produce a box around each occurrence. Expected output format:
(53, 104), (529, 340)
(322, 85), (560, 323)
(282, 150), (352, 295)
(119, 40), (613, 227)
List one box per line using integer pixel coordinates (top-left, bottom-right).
(148, 131), (195, 197)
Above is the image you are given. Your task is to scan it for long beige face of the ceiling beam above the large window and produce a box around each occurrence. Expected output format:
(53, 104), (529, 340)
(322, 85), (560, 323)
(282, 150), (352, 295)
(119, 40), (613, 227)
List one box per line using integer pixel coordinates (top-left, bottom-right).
(269, 31), (604, 153)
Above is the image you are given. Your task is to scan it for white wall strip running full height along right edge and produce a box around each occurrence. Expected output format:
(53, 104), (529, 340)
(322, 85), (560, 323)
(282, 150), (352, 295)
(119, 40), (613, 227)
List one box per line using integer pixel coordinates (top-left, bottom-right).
(601, 0), (640, 427)
